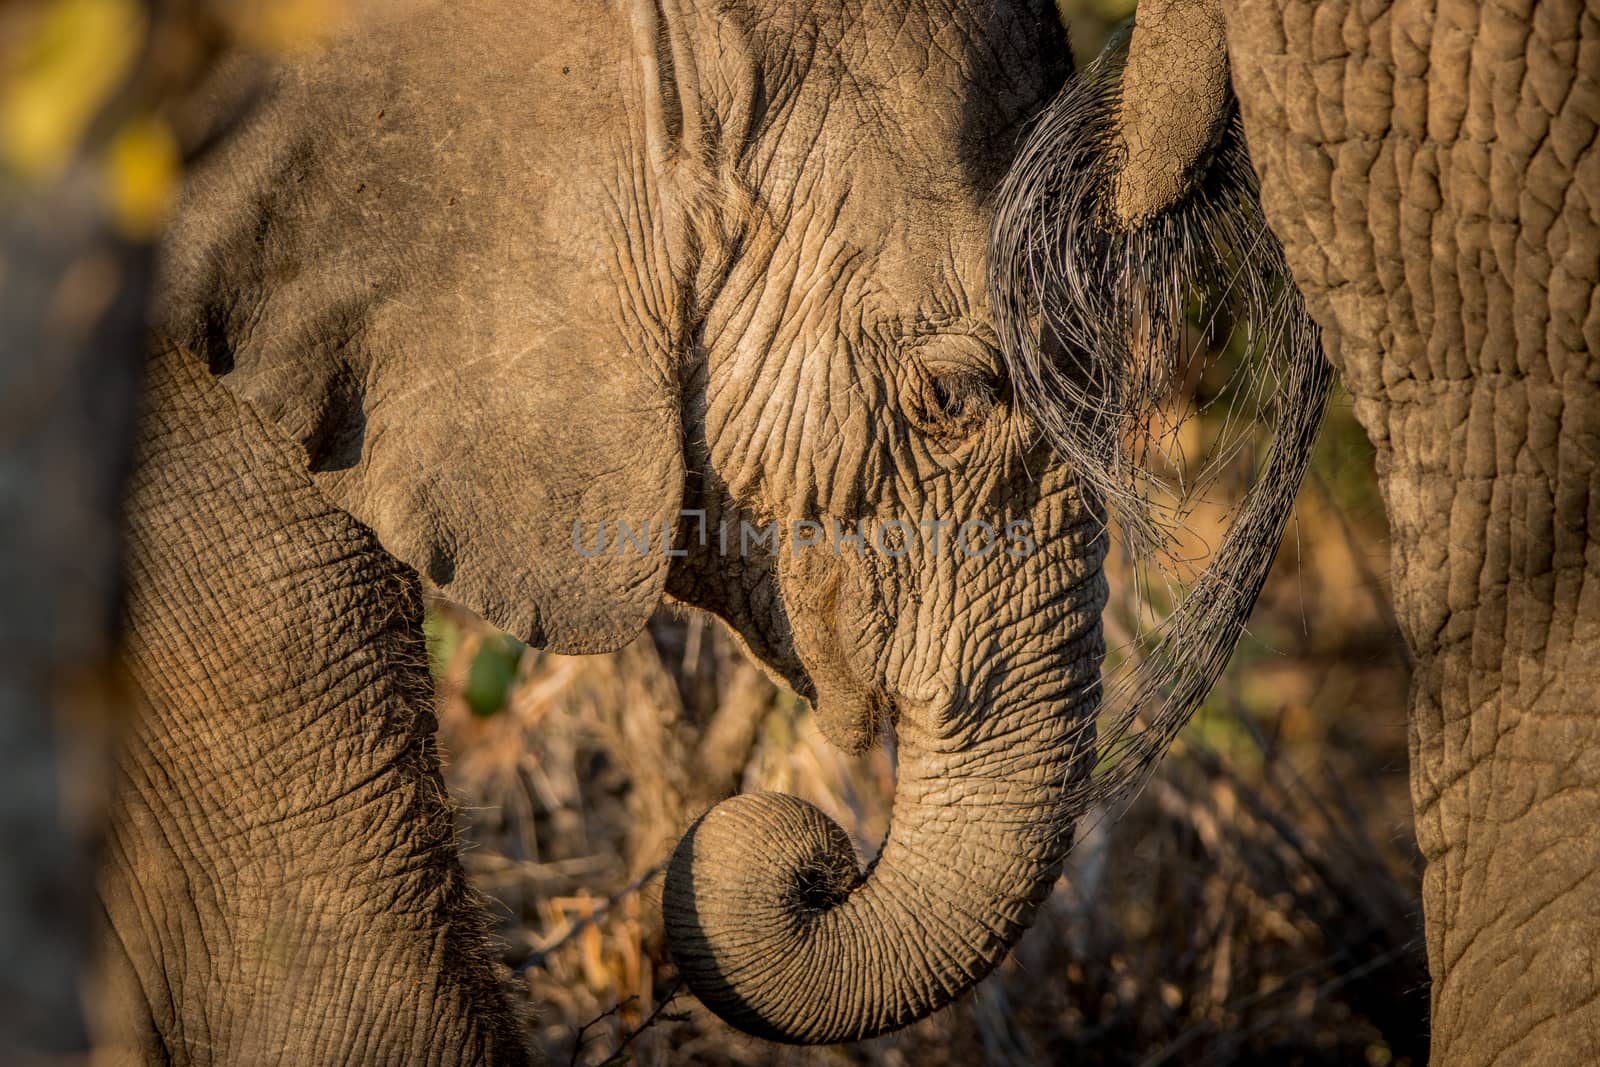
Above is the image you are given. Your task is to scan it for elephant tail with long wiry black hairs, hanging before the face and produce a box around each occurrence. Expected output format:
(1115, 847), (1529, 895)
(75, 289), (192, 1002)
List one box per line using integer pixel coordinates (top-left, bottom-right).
(989, 27), (1333, 811)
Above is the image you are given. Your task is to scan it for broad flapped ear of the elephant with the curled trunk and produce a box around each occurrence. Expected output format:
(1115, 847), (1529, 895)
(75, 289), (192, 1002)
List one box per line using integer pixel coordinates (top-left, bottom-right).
(158, 3), (729, 653)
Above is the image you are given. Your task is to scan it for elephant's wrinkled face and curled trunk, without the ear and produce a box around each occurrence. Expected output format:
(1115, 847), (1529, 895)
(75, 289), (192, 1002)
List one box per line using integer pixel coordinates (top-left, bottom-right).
(643, 5), (1104, 1041)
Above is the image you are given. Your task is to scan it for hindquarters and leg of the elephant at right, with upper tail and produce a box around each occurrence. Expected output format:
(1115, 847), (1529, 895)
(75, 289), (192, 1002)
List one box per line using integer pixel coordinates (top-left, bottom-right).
(992, 0), (1600, 1064)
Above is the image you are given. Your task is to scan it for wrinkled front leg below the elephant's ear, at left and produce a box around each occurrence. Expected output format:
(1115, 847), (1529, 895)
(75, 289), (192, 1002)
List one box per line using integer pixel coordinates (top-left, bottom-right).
(101, 349), (523, 1064)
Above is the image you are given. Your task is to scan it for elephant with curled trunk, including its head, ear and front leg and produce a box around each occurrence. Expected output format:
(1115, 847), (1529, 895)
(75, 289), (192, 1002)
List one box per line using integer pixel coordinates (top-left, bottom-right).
(112, 0), (1104, 1062)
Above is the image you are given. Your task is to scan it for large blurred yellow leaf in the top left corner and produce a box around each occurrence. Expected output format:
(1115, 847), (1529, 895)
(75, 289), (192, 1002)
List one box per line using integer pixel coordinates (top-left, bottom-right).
(0, 0), (144, 179)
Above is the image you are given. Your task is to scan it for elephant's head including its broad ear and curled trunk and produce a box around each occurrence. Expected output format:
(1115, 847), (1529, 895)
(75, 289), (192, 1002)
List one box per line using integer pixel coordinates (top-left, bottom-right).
(152, 0), (1320, 1041)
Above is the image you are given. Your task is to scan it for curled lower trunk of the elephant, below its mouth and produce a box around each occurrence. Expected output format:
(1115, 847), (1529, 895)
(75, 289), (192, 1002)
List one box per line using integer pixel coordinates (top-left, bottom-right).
(662, 652), (1101, 1045)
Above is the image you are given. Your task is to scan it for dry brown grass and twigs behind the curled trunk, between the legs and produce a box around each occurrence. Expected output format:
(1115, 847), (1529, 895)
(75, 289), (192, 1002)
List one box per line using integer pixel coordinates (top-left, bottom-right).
(435, 395), (1426, 1065)
